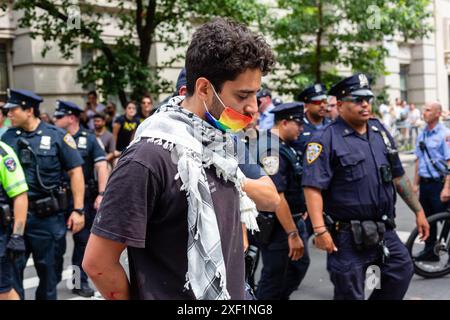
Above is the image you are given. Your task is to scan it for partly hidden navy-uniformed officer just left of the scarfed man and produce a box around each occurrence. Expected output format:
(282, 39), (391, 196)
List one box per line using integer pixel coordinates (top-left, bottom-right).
(54, 101), (108, 297)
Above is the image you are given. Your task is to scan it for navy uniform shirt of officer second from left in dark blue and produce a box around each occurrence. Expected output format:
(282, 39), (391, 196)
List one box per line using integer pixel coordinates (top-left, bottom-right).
(73, 128), (106, 184)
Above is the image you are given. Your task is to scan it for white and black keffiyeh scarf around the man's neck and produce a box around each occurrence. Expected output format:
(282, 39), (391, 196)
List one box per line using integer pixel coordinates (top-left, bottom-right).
(131, 97), (259, 300)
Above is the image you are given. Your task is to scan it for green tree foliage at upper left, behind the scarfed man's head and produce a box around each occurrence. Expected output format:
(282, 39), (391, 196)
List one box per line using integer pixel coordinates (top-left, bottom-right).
(7, 0), (262, 104)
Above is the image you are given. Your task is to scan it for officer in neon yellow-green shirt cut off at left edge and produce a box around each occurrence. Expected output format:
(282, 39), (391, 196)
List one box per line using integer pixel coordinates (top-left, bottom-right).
(0, 142), (28, 300)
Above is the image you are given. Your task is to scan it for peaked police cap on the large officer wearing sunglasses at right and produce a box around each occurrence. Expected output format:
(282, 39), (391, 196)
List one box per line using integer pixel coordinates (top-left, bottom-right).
(328, 73), (373, 100)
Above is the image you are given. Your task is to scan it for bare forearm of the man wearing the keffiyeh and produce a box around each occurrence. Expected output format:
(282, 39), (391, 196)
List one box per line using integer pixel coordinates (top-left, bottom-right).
(83, 234), (130, 300)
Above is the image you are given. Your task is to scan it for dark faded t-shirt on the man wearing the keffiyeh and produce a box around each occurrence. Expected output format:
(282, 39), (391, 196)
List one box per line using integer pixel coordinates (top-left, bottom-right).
(92, 140), (244, 299)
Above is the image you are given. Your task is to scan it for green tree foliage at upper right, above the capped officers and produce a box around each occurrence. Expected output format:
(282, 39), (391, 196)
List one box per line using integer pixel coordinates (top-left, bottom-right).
(261, 0), (431, 93)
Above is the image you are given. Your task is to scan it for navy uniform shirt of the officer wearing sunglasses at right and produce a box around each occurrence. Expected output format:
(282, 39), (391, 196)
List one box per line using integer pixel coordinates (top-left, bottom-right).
(302, 117), (405, 221)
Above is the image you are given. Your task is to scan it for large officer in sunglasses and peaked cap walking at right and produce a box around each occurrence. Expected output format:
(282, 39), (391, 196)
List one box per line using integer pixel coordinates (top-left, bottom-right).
(302, 74), (429, 299)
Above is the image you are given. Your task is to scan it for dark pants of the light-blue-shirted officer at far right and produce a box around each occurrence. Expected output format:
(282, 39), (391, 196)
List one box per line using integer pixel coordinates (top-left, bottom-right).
(419, 182), (448, 251)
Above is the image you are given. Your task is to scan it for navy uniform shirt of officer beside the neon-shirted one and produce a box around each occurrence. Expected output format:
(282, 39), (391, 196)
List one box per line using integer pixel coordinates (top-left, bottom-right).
(2, 121), (83, 200)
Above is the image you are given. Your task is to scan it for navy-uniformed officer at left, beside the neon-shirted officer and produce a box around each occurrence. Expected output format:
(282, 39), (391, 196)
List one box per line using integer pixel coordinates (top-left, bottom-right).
(2, 89), (84, 300)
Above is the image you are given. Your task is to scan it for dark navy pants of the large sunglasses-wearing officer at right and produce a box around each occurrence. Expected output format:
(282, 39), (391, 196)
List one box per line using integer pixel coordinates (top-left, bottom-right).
(327, 230), (413, 300)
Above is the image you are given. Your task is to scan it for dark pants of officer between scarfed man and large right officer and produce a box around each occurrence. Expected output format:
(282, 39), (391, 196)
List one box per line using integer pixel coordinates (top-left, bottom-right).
(256, 219), (310, 300)
